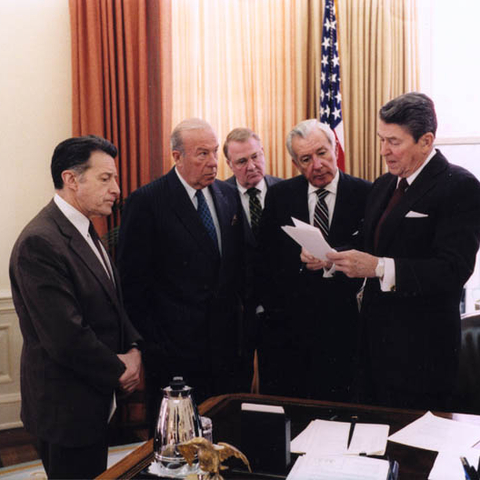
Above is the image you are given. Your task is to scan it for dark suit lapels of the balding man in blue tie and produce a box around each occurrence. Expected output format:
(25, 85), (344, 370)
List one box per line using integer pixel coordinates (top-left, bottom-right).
(167, 169), (223, 257)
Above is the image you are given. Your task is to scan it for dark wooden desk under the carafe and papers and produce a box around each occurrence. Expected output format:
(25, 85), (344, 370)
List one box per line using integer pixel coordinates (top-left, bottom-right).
(98, 394), (480, 480)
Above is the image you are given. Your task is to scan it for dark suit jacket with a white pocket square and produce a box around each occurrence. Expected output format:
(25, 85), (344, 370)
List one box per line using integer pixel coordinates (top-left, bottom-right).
(362, 150), (480, 394)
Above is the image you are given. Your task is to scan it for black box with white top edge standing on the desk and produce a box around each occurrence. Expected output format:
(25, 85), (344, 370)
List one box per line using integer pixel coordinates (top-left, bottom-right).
(241, 403), (291, 473)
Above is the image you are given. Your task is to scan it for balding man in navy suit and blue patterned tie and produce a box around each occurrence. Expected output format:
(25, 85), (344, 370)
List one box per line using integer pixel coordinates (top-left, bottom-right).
(118, 119), (251, 432)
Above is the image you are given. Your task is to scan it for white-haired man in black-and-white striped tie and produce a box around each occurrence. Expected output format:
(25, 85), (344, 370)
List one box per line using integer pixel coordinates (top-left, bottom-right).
(259, 119), (371, 401)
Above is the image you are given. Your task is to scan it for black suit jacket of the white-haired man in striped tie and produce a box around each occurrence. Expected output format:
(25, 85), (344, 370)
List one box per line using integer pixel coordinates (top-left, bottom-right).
(259, 172), (371, 398)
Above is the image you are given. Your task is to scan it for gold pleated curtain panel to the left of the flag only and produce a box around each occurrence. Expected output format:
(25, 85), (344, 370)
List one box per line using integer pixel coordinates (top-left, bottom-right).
(172, 0), (307, 178)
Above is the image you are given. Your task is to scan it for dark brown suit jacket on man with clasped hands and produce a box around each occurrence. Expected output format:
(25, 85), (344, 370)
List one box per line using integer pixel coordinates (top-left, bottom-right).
(10, 200), (140, 447)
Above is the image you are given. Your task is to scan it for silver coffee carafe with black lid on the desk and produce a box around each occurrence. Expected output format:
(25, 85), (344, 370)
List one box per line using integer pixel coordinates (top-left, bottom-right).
(154, 377), (202, 477)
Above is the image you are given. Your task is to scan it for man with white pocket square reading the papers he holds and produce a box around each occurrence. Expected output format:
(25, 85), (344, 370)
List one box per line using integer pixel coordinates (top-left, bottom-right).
(331, 93), (480, 409)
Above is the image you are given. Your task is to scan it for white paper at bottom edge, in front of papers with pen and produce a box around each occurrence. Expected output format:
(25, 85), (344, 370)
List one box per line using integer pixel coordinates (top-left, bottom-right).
(287, 455), (390, 480)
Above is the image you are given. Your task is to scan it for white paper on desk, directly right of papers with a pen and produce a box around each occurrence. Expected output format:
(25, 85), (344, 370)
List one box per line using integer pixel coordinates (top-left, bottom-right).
(388, 412), (480, 452)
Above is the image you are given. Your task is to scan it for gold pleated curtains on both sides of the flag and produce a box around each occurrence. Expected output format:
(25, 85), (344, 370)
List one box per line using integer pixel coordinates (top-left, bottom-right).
(172, 0), (418, 180)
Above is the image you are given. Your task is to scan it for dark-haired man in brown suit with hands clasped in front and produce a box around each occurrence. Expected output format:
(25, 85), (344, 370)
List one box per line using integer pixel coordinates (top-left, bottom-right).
(10, 136), (141, 479)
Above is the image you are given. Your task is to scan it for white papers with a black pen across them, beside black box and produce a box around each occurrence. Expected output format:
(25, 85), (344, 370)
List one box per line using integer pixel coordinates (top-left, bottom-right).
(291, 420), (390, 456)
